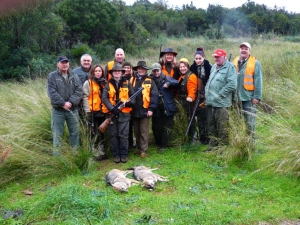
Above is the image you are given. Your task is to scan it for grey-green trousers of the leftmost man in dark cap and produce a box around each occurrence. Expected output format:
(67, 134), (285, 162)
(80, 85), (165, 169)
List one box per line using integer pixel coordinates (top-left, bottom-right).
(51, 108), (79, 155)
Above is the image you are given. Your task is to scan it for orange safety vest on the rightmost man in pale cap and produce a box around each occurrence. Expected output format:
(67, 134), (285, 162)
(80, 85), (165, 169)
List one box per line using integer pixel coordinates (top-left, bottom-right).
(233, 56), (256, 91)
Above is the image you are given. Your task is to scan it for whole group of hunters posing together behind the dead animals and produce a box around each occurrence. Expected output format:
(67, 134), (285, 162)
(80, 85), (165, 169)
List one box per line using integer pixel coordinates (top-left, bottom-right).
(48, 42), (262, 163)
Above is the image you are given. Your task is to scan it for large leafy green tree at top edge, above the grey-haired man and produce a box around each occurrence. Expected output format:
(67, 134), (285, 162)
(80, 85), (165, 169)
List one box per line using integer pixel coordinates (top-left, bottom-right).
(57, 0), (119, 45)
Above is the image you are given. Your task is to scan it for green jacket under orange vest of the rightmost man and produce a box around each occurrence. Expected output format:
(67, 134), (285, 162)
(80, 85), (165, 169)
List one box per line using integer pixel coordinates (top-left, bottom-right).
(235, 56), (262, 101)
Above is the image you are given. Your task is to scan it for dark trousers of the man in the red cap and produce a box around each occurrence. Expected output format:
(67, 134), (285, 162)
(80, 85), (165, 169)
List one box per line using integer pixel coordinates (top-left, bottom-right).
(207, 105), (229, 147)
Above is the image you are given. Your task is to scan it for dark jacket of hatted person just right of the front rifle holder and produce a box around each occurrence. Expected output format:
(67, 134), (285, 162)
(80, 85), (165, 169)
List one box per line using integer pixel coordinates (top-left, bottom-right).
(131, 73), (158, 117)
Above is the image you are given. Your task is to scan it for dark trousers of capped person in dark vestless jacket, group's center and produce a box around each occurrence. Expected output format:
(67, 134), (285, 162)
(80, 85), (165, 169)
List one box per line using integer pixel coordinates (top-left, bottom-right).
(152, 114), (174, 148)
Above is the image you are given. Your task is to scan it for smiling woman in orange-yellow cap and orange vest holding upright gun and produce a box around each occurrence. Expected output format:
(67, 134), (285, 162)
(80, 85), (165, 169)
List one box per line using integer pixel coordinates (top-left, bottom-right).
(177, 58), (198, 142)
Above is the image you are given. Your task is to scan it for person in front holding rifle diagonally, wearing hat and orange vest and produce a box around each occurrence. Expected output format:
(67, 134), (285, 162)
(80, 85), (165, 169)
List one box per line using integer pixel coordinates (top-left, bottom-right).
(102, 63), (135, 163)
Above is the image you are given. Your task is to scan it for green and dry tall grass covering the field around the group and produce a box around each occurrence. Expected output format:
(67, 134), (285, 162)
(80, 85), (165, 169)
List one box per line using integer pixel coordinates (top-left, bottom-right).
(0, 39), (300, 225)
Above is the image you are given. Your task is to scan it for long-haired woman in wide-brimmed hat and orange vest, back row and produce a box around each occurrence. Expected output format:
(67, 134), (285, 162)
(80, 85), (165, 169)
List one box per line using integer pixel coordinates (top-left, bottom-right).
(159, 48), (179, 79)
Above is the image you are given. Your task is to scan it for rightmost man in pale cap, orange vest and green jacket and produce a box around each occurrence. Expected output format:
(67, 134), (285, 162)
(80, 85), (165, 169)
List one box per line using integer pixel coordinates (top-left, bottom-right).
(233, 42), (262, 140)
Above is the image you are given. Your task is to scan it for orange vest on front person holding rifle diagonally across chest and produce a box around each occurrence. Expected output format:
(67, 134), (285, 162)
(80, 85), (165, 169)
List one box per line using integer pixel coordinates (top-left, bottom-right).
(103, 81), (132, 113)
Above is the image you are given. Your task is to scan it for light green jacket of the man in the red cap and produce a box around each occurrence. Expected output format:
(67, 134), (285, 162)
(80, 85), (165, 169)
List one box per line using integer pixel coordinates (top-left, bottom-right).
(205, 60), (237, 107)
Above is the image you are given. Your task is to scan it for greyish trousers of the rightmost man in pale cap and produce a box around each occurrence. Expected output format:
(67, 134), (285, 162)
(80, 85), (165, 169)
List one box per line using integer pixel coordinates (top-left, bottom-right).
(242, 101), (256, 140)
